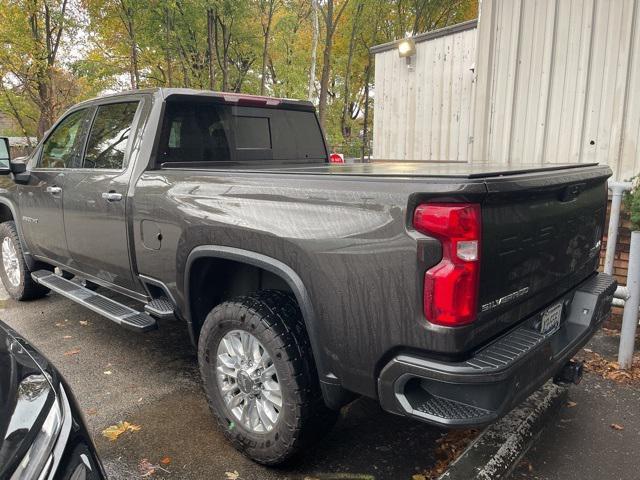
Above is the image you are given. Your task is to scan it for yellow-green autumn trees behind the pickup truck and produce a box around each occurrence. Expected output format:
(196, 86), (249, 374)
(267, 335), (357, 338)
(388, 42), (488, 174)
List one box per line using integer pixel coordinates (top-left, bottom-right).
(0, 0), (477, 144)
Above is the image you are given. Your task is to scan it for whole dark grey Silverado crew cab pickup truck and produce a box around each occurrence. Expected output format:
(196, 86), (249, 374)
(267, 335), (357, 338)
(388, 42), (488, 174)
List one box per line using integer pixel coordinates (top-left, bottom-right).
(0, 89), (615, 464)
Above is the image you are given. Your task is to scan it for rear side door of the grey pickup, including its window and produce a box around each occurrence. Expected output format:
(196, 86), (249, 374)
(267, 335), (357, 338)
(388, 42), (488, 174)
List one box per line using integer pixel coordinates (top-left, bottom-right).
(63, 100), (139, 290)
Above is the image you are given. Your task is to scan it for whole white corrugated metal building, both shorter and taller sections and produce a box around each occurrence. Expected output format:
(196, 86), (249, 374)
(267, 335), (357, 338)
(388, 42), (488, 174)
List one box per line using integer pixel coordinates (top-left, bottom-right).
(373, 0), (640, 179)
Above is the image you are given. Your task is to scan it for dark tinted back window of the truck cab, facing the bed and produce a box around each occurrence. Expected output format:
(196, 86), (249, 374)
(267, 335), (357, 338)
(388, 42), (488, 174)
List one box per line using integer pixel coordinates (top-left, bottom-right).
(157, 101), (326, 168)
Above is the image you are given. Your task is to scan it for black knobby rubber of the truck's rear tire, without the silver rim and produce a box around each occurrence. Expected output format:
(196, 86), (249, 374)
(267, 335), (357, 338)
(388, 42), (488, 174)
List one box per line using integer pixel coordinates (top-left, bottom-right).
(198, 290), (338, 465)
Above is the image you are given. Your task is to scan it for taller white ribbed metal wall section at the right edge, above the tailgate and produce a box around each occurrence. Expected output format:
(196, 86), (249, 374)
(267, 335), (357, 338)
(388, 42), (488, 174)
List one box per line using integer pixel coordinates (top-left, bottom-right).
(471, 0), (640, 179)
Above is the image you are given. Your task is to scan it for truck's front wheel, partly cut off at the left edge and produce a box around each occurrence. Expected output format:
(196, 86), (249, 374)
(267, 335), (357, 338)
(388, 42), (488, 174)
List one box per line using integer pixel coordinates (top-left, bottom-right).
(0, 221), (49, 300)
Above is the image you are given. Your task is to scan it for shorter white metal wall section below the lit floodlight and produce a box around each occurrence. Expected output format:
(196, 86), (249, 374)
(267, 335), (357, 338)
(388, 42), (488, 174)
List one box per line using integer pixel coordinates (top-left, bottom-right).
(373, 28), (476, 161)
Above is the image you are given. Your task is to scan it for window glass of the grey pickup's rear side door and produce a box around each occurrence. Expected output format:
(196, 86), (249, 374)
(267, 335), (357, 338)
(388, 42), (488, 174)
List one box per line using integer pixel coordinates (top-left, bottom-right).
(82, 102), (138, 170)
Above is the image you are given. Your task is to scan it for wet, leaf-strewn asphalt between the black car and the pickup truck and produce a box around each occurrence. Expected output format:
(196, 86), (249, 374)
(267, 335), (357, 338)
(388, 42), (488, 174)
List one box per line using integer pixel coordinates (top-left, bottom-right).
(0, 287), (443, 480)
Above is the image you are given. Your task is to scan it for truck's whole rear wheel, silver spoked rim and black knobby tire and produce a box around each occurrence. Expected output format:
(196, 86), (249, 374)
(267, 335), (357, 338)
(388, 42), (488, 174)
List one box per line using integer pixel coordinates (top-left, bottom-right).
(198, 290), (337, 465)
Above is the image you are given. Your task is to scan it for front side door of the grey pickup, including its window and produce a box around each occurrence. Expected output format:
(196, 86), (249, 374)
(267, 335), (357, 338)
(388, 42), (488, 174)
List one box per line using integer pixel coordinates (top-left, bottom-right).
(17, 109), (87, 265)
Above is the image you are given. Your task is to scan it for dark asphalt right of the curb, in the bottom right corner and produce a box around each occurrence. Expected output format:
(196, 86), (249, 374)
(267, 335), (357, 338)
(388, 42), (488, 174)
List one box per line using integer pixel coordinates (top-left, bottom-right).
(512, 331), (640, 480)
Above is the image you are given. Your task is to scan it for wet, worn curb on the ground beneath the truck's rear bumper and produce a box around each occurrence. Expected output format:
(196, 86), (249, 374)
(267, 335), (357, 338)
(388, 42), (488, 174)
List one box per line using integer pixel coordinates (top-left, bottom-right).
(439, 382), (568, 480)
